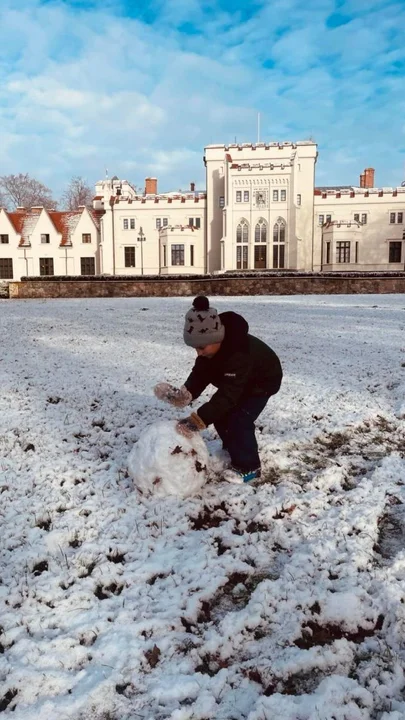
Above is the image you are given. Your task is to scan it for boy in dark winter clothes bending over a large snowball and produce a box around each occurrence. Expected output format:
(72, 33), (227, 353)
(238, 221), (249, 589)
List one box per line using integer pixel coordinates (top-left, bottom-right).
(155, 295), (283, 483)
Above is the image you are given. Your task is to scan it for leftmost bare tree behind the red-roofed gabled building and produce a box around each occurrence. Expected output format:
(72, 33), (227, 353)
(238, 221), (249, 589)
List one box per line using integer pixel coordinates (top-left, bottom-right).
(0, 173), (57, 209)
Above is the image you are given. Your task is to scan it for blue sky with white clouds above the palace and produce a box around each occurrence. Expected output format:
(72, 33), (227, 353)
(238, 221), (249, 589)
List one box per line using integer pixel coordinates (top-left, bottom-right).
(0, 0), (405, 195)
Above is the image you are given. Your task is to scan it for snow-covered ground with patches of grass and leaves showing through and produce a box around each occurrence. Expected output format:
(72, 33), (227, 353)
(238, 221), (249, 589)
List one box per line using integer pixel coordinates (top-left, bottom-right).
(0, 295), (405, 720)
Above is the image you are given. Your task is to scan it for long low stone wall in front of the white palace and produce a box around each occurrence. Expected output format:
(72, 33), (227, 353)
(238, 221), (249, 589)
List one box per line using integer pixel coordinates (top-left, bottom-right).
(10, 273), (405, 299)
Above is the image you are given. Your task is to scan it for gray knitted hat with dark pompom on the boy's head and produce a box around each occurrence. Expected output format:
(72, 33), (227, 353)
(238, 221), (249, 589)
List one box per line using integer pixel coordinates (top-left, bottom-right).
(183, 295), (225, 348)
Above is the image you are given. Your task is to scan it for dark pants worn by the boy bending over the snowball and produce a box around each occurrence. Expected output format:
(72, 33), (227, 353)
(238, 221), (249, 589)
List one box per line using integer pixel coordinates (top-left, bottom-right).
(214, 395), (269, 472)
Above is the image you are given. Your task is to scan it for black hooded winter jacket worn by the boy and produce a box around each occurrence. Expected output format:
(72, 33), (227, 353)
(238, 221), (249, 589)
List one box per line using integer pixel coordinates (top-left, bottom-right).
(184, 312), (283, 426)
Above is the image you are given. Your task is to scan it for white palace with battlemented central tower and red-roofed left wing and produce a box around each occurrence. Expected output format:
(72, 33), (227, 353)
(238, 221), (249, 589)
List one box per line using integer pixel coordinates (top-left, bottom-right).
(0, 141), (405, 280)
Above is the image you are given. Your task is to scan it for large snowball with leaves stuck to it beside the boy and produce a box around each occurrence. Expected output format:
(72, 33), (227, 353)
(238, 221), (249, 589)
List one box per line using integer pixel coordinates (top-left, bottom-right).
(128, 421), (209, 497)
